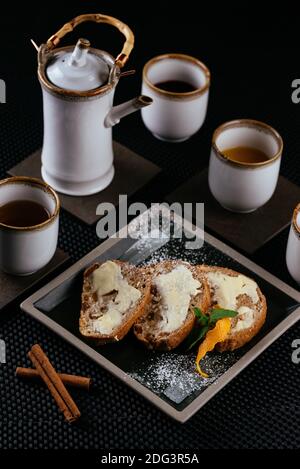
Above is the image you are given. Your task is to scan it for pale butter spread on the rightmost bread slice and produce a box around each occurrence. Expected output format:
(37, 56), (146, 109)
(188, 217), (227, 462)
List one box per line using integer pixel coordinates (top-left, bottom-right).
(207, 272), (259, 332)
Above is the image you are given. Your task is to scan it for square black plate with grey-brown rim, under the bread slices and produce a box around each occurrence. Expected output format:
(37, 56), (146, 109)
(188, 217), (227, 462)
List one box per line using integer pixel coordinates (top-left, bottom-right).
(21, 206), (300, 422)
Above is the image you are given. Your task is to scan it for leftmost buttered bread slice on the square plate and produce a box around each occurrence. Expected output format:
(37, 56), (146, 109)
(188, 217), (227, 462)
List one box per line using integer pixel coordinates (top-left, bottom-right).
(79, 260), (151, 345)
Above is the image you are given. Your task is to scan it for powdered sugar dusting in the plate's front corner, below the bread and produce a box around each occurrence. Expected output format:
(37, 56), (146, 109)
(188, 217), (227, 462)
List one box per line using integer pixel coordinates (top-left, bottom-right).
(130, 350), (238, 404)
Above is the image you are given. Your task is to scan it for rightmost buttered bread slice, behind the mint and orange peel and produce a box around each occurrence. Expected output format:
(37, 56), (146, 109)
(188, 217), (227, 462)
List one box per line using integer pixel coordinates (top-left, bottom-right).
(200, 266), (267, 352)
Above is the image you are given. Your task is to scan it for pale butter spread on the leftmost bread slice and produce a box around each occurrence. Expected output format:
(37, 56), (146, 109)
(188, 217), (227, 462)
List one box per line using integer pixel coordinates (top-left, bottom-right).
(91, 261), (141, 334)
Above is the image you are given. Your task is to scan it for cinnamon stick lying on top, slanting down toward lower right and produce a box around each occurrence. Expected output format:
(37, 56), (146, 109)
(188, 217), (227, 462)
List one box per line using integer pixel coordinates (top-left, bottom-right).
(28, 344), (81, 423)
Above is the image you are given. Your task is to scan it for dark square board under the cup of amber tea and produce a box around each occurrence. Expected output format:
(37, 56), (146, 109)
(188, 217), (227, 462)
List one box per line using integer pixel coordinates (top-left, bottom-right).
(166, 169), (300, 254)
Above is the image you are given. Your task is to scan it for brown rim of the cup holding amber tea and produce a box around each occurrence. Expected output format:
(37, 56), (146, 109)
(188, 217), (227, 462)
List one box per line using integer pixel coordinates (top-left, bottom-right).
(212, 119), (283, 169)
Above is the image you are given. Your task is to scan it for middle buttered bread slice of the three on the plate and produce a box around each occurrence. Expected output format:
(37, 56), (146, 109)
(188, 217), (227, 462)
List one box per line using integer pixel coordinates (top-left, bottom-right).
(133, 260), (210, 351)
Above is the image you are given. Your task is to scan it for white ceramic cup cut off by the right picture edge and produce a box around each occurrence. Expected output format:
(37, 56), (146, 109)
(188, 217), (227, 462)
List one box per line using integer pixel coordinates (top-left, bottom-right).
(286, 204), (300, 284)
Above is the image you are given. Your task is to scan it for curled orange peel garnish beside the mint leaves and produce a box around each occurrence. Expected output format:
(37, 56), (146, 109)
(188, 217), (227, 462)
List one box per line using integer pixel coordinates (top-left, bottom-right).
(196, 318), (231, 378)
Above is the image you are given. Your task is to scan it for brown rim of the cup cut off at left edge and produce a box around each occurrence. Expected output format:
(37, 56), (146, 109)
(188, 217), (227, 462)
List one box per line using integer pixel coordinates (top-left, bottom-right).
(0, 176), (60, 231)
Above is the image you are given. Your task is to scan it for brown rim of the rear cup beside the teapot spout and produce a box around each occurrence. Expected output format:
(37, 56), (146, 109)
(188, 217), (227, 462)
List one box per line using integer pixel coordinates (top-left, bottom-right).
(143, 52), (211, 99)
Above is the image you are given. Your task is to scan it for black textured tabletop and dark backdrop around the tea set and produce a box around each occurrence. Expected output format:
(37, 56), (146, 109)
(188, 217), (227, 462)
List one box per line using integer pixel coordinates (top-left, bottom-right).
(0, 0), (300, 449)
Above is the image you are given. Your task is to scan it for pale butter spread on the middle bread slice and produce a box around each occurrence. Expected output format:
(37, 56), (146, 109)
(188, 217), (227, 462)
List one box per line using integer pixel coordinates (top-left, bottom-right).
(153, 265), (201, 332)
